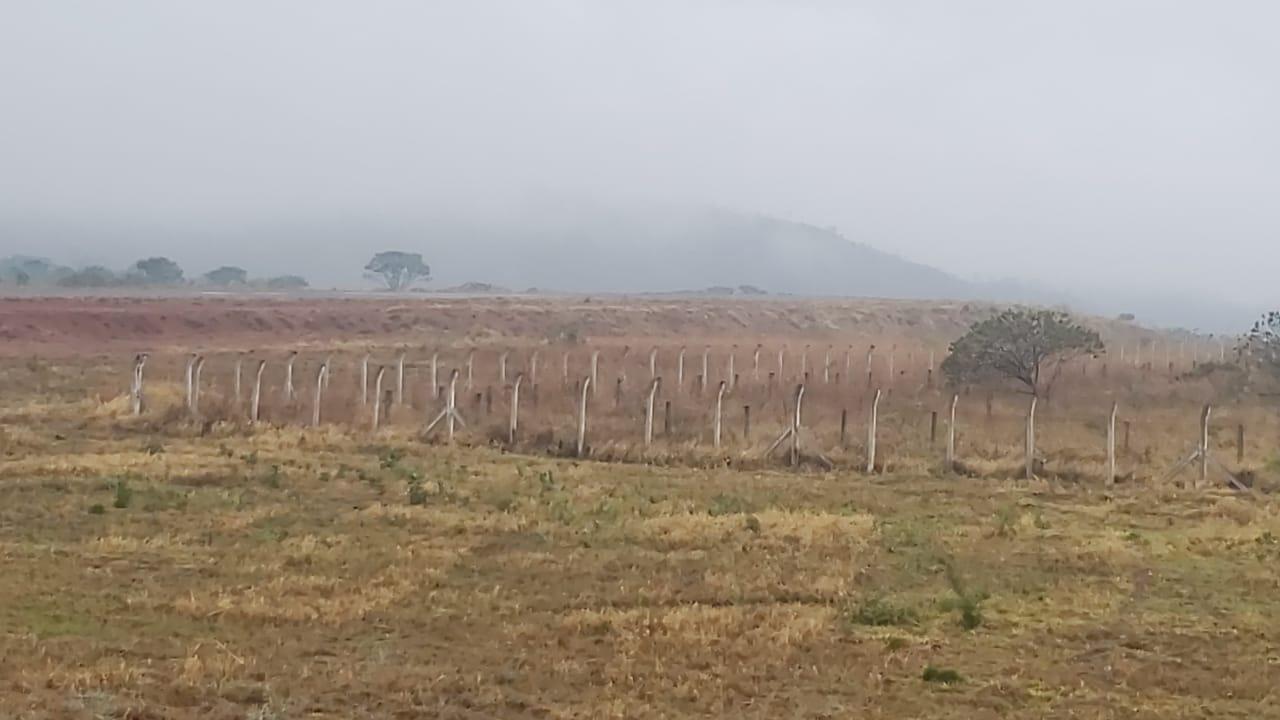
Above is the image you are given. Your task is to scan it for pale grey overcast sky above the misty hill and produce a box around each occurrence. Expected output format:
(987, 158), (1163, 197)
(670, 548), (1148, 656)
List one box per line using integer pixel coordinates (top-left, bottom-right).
(0, 0), (1280, 305)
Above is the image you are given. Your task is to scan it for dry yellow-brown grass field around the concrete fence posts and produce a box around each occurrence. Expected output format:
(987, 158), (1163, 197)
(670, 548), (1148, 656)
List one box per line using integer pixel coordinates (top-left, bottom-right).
(0, 294), (1280, 719)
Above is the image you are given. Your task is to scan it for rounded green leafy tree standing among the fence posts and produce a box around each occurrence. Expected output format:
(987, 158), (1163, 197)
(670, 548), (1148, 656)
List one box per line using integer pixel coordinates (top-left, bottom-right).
(942, 309), (1103, 396)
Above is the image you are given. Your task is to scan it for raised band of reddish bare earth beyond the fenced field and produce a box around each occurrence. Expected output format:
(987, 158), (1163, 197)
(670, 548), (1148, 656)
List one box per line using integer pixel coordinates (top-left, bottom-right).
(0, 296), (980, 355)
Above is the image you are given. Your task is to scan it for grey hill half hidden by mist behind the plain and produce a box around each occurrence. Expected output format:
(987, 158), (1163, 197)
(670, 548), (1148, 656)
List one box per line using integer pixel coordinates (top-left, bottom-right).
(421, 204), (972, 299)
